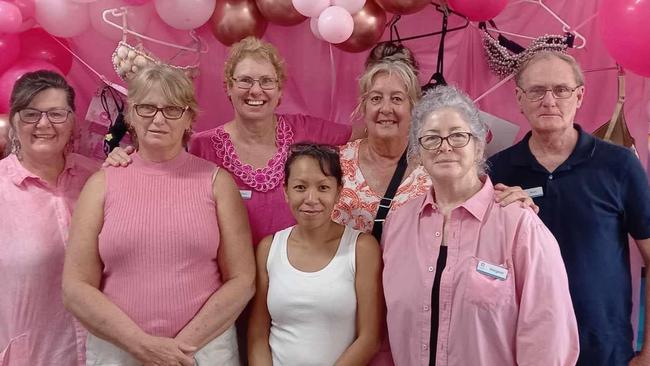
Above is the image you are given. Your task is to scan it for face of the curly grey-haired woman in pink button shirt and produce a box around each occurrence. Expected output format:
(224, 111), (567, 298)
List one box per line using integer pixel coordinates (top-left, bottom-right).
(420, 108), (483, 184)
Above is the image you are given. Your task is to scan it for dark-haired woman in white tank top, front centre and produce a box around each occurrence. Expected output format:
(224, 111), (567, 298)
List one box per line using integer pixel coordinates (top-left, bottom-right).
(248, 144), (384, 366)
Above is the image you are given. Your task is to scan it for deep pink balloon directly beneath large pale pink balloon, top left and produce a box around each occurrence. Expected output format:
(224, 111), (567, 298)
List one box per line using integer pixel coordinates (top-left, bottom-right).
(20, 28), (72, 75)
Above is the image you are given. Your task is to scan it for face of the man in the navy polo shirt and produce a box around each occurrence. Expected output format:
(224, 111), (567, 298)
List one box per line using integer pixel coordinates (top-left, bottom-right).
(516, 57), (584, 133)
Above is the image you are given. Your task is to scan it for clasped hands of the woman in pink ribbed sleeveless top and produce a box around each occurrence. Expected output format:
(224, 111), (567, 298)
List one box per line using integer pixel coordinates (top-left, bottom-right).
(133, 336), (197, 366)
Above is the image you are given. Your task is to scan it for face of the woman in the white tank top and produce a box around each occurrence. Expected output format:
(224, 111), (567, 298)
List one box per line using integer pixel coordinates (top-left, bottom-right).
(284, 156), (341, 227)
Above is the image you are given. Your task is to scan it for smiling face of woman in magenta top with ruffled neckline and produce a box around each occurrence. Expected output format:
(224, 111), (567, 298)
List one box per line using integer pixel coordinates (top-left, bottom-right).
(227, 57), (282, 120)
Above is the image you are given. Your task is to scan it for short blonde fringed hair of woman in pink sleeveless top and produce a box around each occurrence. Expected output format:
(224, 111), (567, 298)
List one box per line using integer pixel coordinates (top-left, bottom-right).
(127, 64), (199, 145)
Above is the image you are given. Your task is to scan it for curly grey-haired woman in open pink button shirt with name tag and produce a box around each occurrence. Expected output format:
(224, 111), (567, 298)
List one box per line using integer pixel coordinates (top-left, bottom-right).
(382, 87), (578, 366)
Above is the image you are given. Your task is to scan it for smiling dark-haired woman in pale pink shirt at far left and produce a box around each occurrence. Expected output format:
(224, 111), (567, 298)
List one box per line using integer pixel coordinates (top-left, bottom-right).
(0, 71), (97, 366)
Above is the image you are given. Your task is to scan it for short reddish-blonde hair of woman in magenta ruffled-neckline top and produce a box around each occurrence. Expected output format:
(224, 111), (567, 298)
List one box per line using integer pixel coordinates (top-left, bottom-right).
(223, 36), (287, 89)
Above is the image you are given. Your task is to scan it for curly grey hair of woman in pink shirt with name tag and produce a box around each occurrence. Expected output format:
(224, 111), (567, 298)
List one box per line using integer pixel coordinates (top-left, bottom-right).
(408, 86), (488, 175)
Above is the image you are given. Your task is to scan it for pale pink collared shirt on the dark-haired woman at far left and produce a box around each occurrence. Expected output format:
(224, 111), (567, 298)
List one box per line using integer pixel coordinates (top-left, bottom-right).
(0, 154), (98, 366)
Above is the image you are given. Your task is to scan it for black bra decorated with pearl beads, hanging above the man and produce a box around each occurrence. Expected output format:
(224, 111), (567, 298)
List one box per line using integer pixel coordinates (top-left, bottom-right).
(479, 21), (575, 77)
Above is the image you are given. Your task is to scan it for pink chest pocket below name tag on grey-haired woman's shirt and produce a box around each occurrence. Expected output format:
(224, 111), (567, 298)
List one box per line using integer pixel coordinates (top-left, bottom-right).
(465, 257), (514, 310)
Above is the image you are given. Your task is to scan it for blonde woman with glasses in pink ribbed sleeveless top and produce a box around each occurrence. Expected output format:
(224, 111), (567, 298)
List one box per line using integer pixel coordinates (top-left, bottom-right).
(63, 66), (255, 366)
